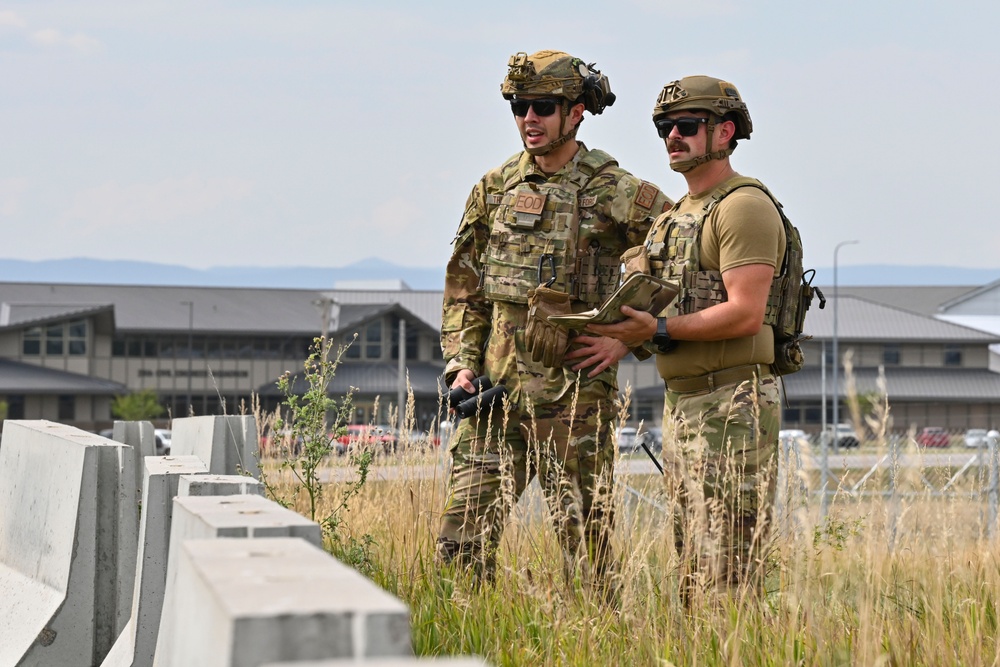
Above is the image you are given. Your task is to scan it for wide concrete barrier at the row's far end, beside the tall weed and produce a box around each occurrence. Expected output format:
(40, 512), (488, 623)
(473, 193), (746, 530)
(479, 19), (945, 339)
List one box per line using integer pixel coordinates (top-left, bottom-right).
(170, 415), (260, 477)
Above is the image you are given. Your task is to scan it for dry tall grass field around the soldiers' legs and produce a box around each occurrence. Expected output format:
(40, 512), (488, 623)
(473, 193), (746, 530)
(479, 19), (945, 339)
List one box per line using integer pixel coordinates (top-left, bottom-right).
(254, 386), (1000, 665)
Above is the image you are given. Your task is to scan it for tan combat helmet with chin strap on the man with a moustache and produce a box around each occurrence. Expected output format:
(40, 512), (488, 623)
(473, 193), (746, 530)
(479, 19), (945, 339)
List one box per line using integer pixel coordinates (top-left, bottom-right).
(653, 75), (753, 172)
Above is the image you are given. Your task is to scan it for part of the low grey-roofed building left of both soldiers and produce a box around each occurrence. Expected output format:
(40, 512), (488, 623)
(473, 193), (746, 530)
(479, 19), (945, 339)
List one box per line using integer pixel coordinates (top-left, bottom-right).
(0, 283), (444, 430)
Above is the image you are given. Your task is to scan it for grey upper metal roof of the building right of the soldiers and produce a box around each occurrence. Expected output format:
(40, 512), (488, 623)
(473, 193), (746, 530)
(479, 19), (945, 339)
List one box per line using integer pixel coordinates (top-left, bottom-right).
(804, 294), (1000, 345)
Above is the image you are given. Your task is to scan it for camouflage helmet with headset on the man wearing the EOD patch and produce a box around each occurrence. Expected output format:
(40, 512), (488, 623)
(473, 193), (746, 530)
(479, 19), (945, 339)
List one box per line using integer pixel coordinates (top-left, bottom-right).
(500, 50), (615, 155)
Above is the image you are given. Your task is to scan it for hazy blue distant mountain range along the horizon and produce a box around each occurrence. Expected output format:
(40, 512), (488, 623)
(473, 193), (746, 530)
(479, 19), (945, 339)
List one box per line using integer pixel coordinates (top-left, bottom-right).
(0, 257), (1000, 290)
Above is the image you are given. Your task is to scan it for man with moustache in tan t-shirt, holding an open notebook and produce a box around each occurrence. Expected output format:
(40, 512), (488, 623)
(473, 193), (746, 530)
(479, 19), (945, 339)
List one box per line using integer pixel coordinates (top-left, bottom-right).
(589, 76), (786, 592)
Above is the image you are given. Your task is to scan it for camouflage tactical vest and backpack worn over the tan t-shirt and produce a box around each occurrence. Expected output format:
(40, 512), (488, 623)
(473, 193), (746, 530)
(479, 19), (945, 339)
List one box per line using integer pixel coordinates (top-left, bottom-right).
(646, 176), (826, 375)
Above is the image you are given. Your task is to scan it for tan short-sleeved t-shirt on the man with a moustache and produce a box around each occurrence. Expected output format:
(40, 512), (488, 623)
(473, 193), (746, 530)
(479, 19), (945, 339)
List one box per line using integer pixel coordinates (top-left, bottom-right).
(656, 180), (785, 380)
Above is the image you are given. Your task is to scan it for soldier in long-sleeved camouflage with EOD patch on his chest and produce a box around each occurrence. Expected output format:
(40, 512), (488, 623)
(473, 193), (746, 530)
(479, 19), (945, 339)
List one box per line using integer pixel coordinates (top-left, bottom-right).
(437, 51), (670, 584)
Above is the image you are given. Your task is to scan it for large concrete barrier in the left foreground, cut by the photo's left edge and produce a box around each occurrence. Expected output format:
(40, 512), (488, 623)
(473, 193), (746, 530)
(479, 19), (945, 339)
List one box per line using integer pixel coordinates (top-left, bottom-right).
(0, 420), (138, 667)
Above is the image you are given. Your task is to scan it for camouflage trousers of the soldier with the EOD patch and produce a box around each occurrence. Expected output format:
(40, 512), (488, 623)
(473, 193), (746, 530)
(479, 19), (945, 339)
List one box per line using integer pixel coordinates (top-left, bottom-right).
(437, 382), (617, 586)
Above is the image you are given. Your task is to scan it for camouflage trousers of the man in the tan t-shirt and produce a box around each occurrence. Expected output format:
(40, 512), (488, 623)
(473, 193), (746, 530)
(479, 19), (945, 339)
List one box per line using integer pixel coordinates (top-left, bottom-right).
(663, 367), (781, 594)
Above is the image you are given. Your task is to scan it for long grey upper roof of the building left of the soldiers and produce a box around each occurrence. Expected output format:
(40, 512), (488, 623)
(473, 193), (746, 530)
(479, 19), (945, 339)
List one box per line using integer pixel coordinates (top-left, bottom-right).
(0, 282), (441, 336)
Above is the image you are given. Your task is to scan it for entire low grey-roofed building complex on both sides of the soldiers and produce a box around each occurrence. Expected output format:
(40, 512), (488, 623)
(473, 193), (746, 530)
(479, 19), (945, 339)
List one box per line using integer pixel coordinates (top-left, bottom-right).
(0, 283), (1000, 432)
